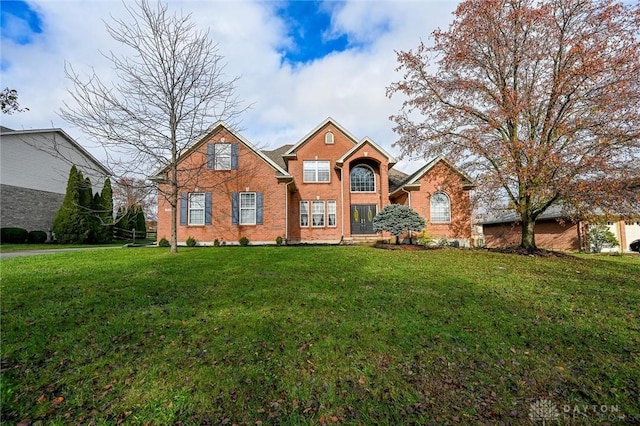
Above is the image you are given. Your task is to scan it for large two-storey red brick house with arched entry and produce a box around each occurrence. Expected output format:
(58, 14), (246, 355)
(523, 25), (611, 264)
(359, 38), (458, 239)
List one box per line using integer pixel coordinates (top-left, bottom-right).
(154, 118), (471, 245)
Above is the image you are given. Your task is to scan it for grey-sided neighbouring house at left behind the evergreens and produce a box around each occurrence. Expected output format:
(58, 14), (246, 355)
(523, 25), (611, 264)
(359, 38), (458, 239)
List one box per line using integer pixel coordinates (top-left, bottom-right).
(0, 127), (110, 231)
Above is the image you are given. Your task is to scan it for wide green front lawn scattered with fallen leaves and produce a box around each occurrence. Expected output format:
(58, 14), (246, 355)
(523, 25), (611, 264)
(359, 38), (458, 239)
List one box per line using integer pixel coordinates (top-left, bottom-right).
(0, 247), (640, 425)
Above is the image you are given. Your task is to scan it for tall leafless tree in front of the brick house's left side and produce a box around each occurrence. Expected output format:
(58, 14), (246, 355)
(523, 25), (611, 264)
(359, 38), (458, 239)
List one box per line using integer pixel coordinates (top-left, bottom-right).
(60, 0), (245, 253)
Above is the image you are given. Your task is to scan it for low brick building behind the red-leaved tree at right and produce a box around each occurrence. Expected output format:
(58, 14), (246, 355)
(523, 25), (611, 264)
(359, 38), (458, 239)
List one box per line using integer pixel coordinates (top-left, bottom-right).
(482, 207), (640, 251)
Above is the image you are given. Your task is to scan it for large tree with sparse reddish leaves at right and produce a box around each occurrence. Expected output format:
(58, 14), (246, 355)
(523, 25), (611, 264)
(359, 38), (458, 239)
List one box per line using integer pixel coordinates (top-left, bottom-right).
(387, 0), (640, 249)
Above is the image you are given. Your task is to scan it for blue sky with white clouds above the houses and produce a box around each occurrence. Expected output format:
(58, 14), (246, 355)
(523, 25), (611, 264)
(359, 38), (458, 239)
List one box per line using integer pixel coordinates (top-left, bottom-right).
(0, 0), (458, 172)
